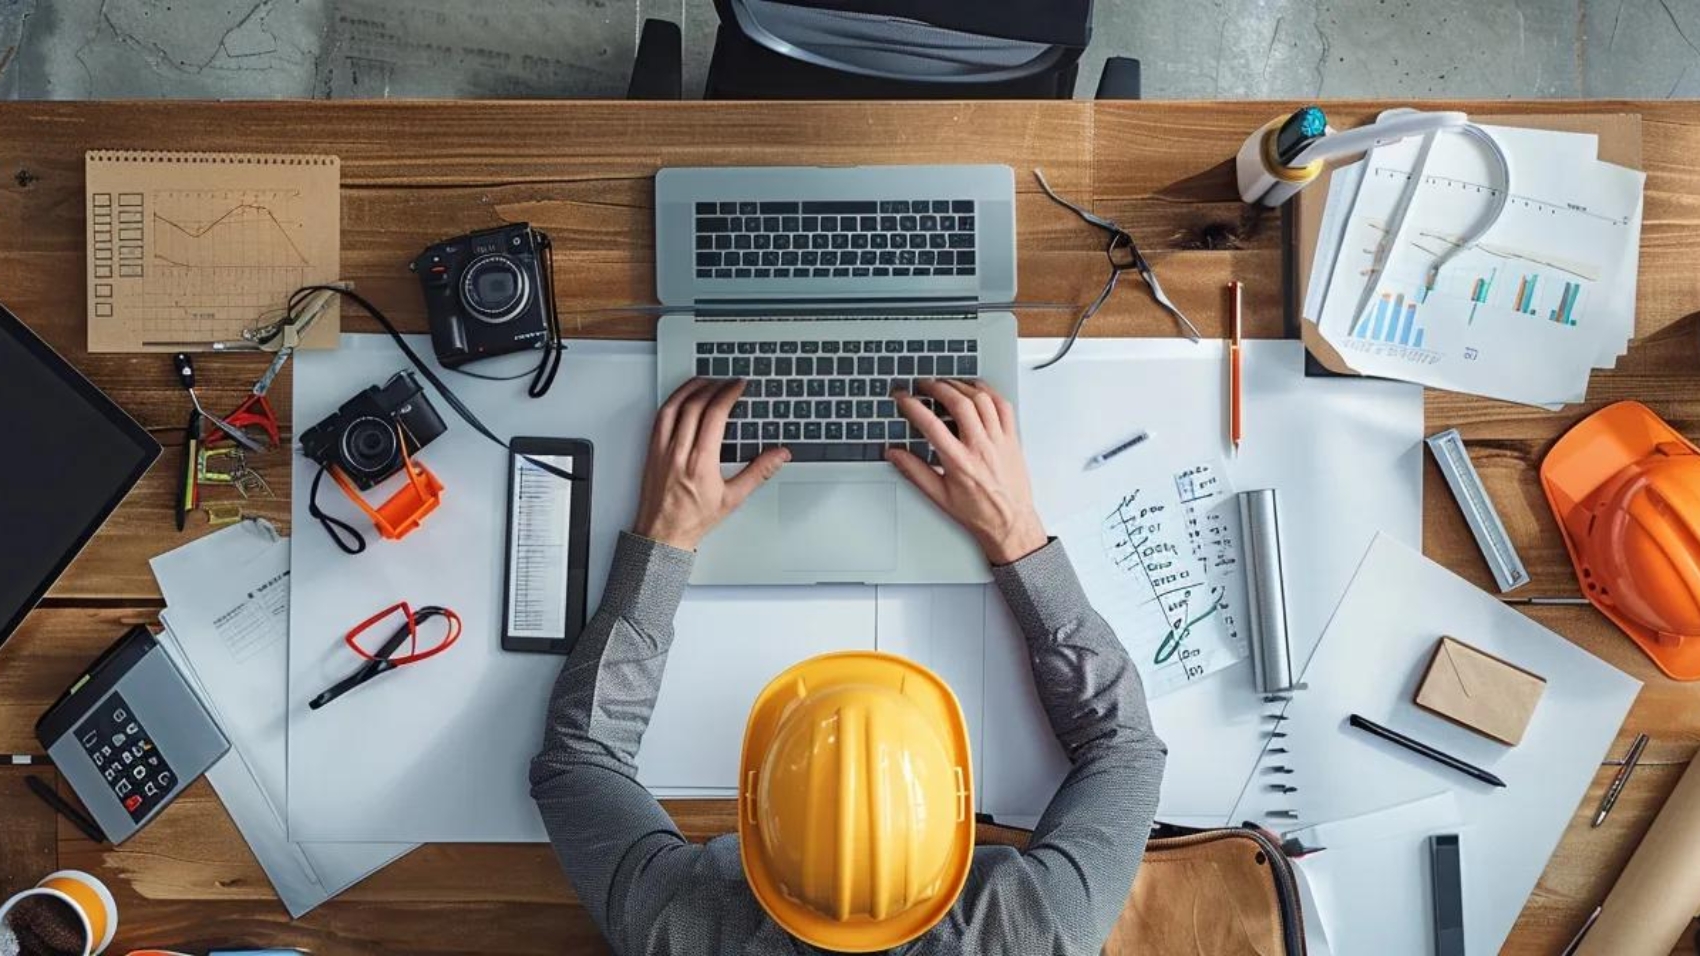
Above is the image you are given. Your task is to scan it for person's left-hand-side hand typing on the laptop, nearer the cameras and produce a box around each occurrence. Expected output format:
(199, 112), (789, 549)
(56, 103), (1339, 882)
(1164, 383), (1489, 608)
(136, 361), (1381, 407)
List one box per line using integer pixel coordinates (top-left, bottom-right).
(632, 378), (791, 551)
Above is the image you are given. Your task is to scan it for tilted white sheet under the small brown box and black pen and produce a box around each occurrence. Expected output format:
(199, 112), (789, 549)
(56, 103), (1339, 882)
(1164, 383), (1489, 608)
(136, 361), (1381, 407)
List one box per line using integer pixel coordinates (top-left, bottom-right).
(1234, 538), (1641, 953)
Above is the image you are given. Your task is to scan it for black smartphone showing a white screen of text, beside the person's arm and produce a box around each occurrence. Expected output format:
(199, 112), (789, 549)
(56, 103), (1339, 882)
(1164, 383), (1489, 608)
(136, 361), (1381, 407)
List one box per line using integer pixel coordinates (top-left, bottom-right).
(502, 437), (595, 653)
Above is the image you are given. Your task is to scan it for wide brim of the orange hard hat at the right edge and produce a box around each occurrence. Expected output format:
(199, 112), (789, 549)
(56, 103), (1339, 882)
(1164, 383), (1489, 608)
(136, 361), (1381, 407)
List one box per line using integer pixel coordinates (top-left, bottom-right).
(1540, 401), (1700, 680)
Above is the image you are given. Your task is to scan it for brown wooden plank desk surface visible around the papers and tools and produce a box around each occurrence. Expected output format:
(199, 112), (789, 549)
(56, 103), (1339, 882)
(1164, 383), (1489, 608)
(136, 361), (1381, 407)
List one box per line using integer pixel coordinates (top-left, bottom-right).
(0, 102), (1700, 954)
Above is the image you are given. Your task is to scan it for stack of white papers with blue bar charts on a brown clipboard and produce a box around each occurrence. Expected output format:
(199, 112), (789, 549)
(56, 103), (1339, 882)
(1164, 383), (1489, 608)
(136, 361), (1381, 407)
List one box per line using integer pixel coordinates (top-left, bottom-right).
(1304, 116), (1646, 408)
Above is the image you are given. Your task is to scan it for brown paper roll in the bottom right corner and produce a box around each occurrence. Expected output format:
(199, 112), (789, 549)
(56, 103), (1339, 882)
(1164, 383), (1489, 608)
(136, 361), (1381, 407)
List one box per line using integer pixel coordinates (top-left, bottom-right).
(1576, 759), (1700, 956)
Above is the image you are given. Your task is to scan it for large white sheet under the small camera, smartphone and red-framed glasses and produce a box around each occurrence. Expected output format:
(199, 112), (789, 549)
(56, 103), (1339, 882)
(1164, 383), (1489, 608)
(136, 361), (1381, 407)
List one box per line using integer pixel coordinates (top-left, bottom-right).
(289, 335), (876, 842)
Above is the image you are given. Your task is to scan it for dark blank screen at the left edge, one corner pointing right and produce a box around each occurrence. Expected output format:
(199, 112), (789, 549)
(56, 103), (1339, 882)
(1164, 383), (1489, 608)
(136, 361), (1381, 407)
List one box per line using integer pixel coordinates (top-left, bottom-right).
(0, 306), (160, 645)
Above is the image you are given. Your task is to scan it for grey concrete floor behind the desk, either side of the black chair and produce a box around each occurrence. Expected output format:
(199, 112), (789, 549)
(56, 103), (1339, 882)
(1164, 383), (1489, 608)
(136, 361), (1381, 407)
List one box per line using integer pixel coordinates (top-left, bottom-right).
(0, 0), (1700, 99)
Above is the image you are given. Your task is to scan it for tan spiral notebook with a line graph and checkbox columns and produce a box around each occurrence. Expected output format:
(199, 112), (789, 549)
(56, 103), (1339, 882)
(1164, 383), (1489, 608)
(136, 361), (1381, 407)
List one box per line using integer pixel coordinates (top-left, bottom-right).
(85, 150), (342, 352)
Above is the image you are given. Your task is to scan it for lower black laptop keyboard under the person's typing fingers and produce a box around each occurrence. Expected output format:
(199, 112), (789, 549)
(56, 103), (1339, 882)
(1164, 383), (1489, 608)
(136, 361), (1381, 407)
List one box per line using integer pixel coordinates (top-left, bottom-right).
(697, 339), (979, 463)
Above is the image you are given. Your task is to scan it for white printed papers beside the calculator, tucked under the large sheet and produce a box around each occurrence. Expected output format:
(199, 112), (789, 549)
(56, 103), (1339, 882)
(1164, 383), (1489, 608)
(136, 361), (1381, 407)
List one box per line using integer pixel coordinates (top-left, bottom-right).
(151, 521), (413, 919)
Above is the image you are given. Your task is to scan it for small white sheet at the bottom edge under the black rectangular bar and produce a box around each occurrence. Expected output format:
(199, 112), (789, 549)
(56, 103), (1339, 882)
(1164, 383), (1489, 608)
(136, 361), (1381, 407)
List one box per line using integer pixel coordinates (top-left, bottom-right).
(1287, 791), (1462, 956)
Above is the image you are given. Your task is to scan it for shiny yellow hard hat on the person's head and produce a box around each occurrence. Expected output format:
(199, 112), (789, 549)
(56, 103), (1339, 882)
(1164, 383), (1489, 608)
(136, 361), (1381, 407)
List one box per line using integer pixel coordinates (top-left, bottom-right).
(738, 652), (974, 953)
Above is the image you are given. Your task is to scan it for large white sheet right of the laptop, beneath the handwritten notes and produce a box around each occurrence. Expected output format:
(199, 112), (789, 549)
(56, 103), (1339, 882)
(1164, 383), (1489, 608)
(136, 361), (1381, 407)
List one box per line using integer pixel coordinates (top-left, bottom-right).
(911, 339), (1423, 825)
